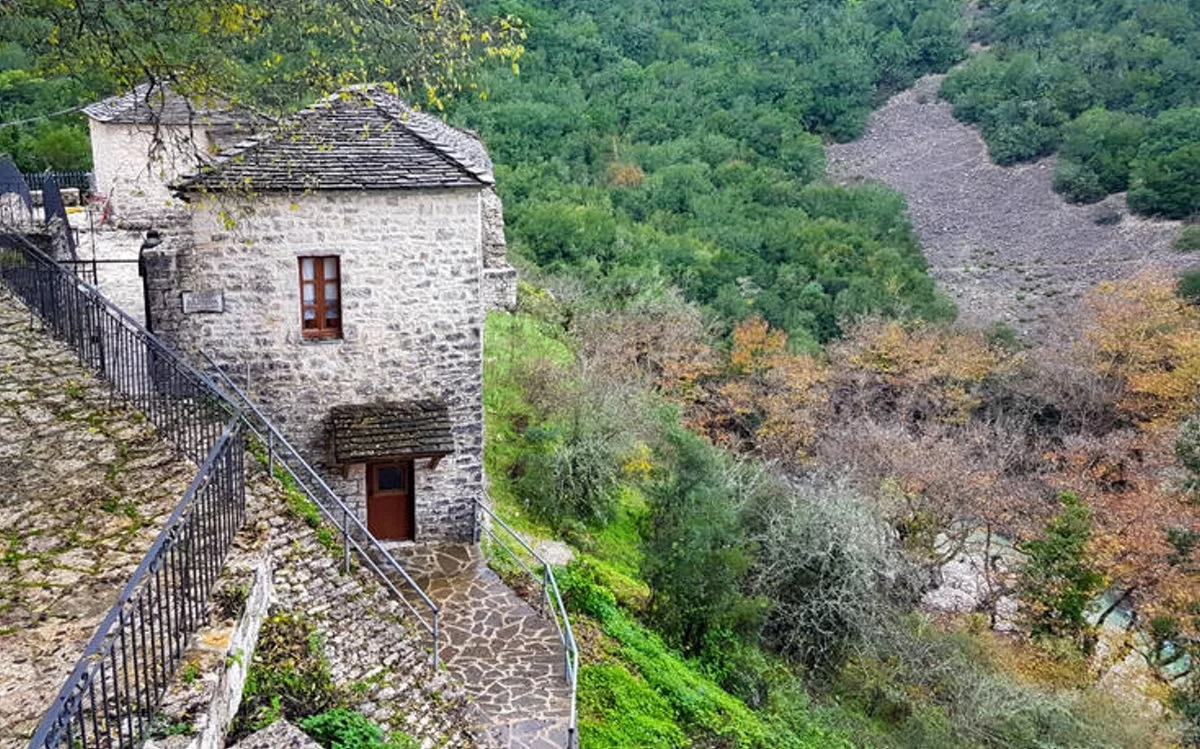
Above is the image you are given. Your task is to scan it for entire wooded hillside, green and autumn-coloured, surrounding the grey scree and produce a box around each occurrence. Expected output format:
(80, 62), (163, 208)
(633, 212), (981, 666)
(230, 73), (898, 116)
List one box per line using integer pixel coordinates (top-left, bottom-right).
(7, 0), (1200, 749)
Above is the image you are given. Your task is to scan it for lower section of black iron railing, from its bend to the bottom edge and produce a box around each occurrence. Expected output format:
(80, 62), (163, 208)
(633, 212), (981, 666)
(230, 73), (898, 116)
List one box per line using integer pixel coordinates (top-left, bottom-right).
(29, 418), (246, 749)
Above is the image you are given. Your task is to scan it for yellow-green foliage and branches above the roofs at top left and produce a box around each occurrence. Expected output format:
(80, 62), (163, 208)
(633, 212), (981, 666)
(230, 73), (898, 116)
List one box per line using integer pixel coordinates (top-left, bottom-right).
(0, 0), (523, 170)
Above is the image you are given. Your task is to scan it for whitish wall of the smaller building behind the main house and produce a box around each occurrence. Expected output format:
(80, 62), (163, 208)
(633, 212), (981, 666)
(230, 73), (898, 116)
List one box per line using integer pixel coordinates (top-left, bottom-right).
(89, 120), (209, 227)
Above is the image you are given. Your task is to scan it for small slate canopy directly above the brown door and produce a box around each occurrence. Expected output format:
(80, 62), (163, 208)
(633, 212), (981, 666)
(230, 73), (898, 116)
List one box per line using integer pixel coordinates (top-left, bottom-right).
(329, 400), (454, 465)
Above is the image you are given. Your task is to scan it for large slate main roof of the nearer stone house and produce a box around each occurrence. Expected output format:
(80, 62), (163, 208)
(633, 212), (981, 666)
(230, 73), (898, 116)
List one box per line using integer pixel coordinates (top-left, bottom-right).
(175, 84), (496, 192)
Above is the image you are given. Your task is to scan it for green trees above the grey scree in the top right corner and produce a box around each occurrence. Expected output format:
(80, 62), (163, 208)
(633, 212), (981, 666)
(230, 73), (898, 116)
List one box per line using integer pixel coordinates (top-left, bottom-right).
(942, 0), (1200, 218)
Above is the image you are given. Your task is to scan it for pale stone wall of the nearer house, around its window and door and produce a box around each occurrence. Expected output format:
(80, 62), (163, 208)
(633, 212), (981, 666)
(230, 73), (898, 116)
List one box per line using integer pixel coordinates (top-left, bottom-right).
(145, 190), (484, 541)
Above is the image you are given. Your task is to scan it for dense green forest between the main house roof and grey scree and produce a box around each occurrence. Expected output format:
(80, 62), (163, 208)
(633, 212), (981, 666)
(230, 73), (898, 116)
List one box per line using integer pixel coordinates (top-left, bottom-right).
(455, 0), (964, 346)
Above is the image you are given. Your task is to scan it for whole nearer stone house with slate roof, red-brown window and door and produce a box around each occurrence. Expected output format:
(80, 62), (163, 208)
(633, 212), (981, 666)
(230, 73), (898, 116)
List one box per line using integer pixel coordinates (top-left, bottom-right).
(133, 85), (516, 543)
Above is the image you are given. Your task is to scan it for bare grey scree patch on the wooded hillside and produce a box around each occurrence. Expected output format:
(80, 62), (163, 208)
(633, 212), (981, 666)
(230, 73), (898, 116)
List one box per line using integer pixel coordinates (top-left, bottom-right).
(827, 76), (1185, 337)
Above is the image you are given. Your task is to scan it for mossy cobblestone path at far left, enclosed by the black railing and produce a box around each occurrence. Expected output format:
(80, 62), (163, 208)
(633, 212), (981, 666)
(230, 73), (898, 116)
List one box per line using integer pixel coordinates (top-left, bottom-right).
(0, 289), (196, 748)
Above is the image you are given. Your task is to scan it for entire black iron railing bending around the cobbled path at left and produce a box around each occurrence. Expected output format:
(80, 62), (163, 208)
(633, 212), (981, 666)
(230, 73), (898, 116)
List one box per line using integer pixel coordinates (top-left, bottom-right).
(0, 232), (246, 749)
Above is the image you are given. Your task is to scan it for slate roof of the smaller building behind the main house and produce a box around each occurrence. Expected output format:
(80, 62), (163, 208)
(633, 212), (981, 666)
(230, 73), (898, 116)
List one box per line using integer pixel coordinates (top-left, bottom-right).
(83, 83), (262, 126)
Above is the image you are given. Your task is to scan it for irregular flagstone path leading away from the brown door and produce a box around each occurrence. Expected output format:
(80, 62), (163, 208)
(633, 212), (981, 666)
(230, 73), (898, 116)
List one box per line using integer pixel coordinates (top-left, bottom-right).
(401, 545), (570, 749)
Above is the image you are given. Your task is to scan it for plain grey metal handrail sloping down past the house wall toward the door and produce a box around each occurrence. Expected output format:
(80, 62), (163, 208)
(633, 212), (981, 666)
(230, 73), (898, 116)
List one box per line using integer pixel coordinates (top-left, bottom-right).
(202, 352), (440, 669)
